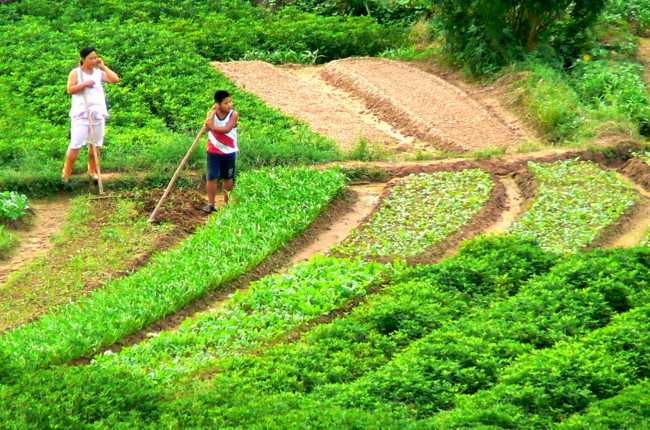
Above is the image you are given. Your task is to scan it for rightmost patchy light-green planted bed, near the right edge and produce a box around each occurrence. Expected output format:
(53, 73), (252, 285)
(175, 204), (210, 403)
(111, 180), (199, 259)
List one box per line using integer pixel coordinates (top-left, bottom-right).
(510, 160), (639, 253)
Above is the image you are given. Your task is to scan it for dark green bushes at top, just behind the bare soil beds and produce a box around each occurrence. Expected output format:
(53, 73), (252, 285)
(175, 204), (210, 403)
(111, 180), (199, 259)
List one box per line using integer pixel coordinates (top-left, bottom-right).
(176, 8), (405, 63)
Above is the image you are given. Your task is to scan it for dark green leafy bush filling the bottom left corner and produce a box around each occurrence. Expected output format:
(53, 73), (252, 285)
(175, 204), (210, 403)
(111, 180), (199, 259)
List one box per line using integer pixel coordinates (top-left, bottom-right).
(0, 366), (161, 429)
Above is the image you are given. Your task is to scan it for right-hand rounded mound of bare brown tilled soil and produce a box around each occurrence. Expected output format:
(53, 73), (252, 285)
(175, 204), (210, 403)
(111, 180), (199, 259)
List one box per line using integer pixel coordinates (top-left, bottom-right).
(320, 58), (521, 152)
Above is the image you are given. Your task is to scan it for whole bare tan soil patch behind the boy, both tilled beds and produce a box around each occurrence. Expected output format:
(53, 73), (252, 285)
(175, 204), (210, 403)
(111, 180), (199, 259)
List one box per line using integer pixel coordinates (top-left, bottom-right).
(212, 58), (534, 154)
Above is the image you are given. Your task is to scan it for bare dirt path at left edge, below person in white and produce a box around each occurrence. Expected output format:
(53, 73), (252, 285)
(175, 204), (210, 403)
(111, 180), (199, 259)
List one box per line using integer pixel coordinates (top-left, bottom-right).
(0, 197), (70, 288)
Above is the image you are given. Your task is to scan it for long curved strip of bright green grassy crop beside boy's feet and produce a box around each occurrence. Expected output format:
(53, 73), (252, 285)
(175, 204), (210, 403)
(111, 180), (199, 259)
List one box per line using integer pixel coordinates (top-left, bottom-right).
(0, 167), (345, 368)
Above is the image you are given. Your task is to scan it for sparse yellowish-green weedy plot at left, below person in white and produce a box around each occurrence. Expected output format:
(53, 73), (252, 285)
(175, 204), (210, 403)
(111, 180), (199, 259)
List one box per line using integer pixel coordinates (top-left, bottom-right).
(0, 196), (172, 331)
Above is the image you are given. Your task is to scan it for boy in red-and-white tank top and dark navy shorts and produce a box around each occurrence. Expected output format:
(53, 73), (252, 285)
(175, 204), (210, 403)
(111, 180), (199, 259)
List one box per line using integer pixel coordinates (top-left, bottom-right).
(205, 90), (239, 213)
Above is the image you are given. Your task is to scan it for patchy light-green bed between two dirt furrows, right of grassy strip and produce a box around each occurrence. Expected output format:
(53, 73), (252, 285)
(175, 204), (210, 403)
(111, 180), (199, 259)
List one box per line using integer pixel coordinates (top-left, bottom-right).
(332, 169), (493, 258)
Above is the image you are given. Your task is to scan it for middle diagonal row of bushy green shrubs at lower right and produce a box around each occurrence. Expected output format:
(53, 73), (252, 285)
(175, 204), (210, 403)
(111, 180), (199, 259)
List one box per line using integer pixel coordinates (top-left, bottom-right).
(317, 247), (650, 417)
